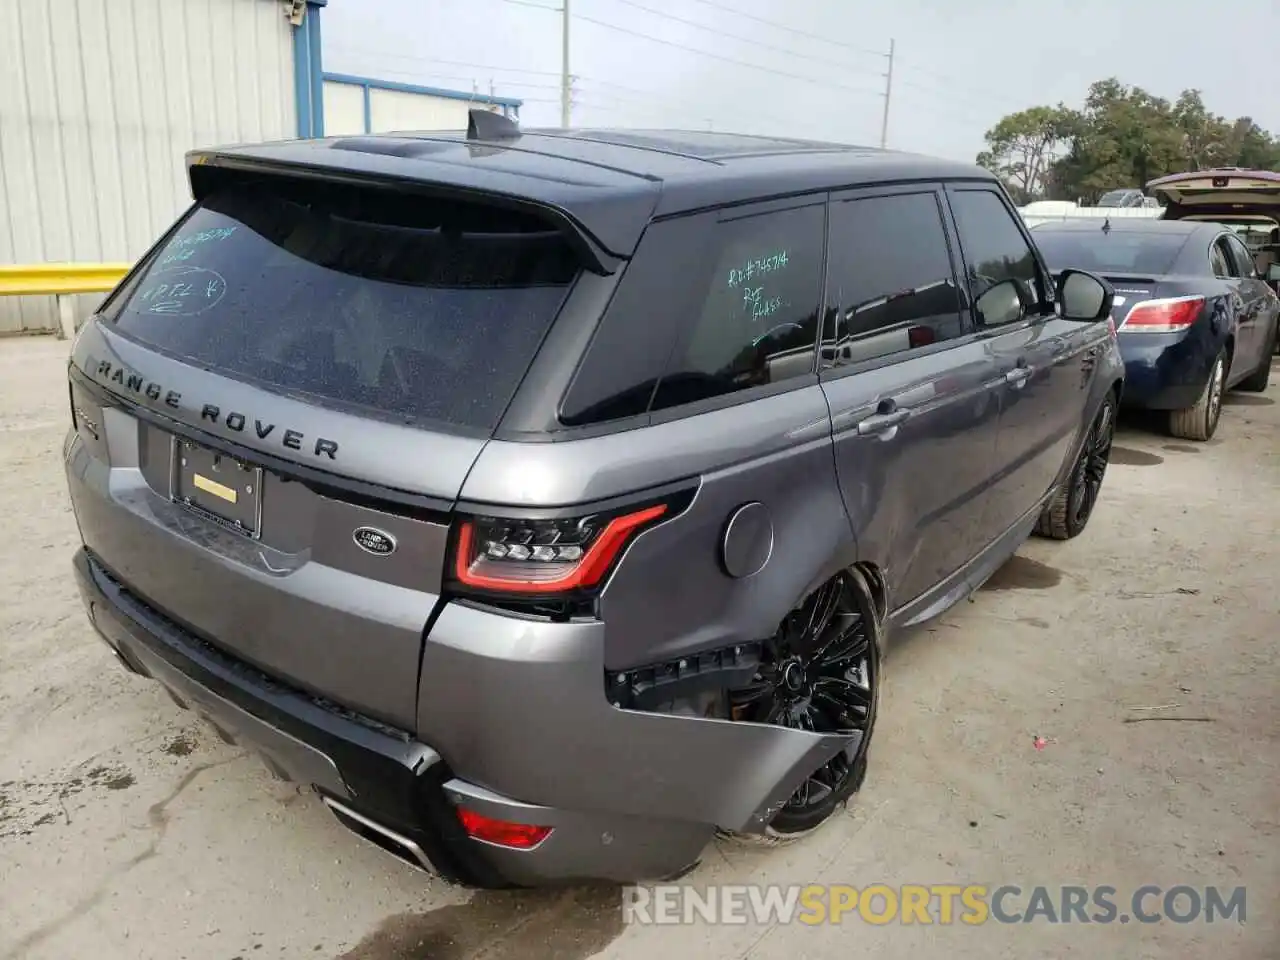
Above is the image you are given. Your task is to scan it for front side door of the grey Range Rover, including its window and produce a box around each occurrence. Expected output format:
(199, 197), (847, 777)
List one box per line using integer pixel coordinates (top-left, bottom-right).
(947, 186), (1096, 532)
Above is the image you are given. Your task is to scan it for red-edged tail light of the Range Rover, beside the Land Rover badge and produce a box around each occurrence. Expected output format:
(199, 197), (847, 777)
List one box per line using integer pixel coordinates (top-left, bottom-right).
(453, 502), (677, 595)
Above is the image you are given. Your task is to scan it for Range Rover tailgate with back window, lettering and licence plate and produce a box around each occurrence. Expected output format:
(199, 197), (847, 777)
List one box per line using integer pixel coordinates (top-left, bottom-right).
(69, 179), (577, 728)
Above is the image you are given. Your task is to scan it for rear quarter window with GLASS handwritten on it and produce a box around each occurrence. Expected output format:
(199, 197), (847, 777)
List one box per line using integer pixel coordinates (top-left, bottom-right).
(652, 204), (824, 410)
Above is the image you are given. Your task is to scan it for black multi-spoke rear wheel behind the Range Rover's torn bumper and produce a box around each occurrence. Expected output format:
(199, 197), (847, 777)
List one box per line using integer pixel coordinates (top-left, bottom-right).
(721, 570), (882, 845)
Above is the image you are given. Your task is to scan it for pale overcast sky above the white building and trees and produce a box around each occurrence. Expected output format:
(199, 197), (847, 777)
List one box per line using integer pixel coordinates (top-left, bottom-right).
(321, 0), (1280, 160)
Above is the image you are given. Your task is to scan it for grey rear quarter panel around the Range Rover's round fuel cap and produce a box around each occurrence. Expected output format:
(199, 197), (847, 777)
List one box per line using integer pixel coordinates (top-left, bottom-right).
(450, 378), (856, 669)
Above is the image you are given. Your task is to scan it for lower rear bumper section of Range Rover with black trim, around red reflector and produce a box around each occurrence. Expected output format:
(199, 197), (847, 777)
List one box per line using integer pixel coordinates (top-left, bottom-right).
(73, 549), (713, 887)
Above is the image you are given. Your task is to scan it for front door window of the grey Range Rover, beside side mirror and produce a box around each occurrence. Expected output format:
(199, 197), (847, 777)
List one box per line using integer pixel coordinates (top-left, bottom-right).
(951, 189), (1039, 326)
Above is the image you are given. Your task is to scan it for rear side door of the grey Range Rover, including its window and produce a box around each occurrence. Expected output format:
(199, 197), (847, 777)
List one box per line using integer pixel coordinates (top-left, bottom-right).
(822, 184), (998, 607)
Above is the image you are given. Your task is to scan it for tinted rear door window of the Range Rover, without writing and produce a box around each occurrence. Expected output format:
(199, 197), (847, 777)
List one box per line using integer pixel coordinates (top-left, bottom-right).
(822, 192), (963, 366)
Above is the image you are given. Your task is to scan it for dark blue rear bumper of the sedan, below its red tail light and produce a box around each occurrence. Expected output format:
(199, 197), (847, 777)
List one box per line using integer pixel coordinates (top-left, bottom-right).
(1119, 326), (1221, 410)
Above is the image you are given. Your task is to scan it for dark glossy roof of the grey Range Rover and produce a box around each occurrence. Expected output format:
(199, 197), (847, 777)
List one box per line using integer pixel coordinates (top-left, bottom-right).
(188, 129), (995, 267)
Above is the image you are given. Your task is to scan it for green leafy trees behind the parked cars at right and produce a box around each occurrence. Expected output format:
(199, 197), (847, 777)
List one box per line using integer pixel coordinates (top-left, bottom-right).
(978, 77), (1280, 202)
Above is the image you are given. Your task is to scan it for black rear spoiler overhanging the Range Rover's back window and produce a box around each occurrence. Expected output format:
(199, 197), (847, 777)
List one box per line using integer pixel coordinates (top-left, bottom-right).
(186, 150), (632, 275)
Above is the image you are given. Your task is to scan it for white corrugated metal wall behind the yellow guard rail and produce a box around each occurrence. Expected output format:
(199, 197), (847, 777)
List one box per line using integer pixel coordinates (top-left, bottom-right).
(0, 0), (297, 333)
